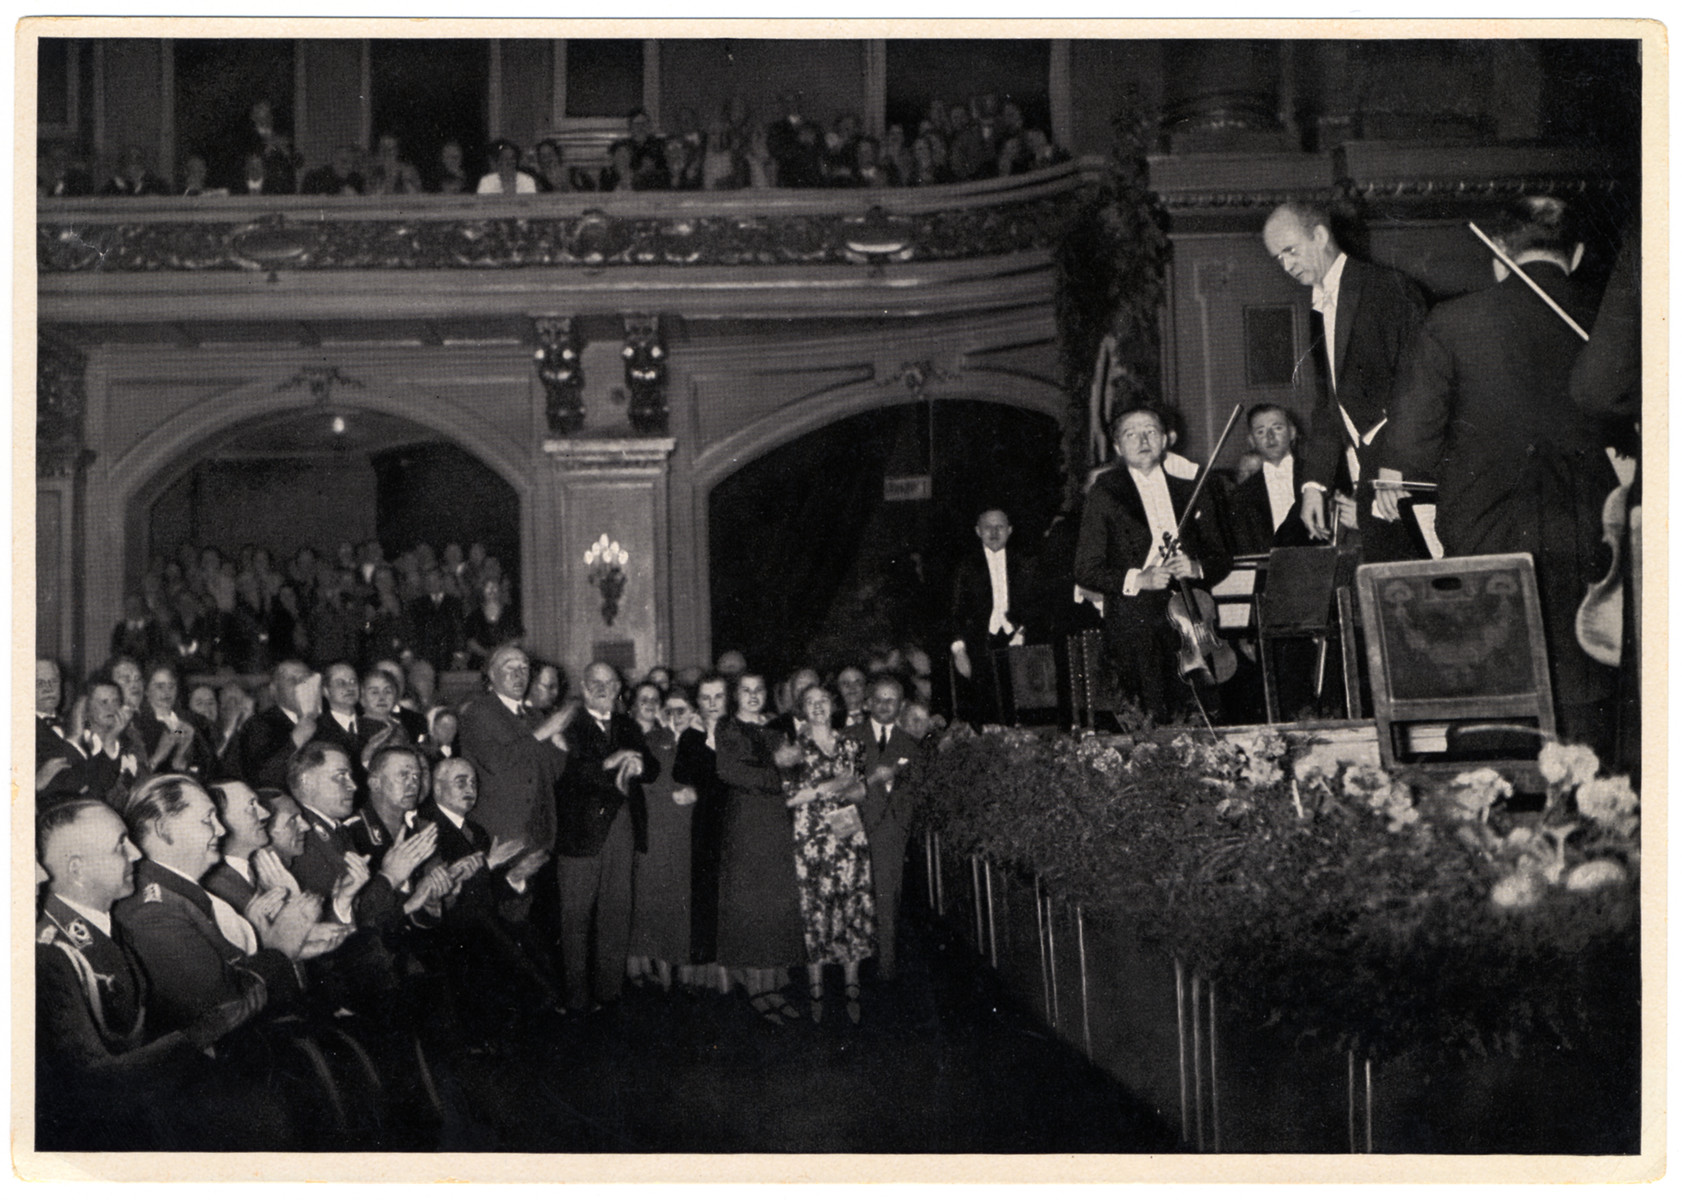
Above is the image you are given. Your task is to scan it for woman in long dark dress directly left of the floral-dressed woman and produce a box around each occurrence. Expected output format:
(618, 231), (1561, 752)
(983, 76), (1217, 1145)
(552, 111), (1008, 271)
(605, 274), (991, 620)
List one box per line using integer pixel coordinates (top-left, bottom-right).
(718, 675), (806, 1025)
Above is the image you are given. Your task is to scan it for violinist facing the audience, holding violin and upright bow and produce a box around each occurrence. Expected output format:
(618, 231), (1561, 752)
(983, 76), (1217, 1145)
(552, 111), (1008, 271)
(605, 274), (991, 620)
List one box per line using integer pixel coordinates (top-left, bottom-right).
(1075, 407), (1231, 720)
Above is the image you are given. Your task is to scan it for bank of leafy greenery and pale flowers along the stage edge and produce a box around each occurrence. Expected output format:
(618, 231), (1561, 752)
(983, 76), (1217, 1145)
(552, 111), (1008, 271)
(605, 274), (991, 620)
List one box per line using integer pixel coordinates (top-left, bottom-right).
(903, 727), (1640, 1055)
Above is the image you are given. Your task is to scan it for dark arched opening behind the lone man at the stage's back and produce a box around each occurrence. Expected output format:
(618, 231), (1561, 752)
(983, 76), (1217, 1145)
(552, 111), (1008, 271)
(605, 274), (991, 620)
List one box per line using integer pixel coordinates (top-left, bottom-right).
(708, 399), (1061, 675)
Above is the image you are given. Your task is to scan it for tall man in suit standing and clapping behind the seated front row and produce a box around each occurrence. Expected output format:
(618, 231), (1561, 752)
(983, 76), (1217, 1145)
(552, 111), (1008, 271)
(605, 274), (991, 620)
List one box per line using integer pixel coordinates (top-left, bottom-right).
(456, 646), (570, 850)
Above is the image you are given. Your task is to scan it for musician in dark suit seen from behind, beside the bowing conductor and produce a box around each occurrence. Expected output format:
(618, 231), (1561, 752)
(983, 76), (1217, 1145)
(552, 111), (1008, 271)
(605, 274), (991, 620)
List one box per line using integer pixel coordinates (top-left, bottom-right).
(1383, 197), (1618, 754)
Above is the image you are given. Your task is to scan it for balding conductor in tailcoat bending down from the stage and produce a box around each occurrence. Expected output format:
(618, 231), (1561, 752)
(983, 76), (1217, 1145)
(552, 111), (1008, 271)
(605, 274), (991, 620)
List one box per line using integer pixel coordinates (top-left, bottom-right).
(1262, 202), (1425, 562)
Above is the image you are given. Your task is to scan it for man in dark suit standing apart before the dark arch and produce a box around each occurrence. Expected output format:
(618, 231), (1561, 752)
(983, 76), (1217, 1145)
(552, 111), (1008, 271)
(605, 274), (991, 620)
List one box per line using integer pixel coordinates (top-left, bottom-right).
(950, 508), (1033, 724)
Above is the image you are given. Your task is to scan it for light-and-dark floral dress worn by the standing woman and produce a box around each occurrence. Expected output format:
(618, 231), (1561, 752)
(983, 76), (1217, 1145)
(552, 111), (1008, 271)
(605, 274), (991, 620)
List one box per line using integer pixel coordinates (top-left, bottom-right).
(784, 729), (876, 963)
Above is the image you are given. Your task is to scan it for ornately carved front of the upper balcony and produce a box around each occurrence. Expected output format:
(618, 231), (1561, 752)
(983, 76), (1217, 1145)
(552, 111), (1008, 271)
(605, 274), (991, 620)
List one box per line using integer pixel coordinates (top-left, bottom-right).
(35, 160), (1102, 274)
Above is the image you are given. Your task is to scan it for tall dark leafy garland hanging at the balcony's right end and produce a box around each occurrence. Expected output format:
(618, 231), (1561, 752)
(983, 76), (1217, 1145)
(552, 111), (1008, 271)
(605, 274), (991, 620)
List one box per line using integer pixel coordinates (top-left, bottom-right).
(1053, 91), (1171, 507)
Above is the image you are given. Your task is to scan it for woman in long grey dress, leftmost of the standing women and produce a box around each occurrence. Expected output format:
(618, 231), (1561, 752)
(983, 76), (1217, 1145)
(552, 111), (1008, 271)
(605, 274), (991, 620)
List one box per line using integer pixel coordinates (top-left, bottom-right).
(626, 683), (695, 991)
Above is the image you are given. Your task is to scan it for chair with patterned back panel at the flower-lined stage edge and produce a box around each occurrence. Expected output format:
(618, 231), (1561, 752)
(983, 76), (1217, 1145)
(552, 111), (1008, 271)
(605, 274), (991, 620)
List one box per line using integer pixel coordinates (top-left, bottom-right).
(1356, 554), (1554, 791)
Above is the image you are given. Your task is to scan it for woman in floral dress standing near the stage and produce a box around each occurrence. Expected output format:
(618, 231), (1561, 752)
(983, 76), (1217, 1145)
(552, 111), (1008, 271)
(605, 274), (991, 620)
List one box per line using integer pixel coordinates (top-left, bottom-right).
(784, 685), (876, 1025)
